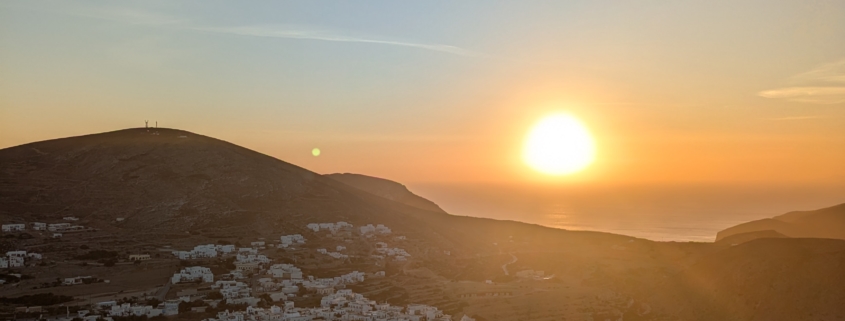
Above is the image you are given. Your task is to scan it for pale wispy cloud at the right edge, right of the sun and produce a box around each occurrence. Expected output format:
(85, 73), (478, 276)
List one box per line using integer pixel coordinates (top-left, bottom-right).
(757, 59), (845, 104)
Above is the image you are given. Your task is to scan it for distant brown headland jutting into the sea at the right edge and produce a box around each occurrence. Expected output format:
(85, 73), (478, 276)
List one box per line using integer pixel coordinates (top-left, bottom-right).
(716, 204), (845, 241)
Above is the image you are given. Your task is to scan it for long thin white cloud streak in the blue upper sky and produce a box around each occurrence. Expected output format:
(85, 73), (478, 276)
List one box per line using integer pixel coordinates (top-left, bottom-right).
(191, 26), (480, 57)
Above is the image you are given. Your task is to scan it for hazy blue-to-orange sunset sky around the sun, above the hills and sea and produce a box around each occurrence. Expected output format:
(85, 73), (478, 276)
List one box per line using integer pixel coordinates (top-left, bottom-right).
(0, 1), (845, 184)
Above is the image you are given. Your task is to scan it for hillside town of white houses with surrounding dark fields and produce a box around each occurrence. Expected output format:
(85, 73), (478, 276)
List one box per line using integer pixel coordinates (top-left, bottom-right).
(0, 217), (511, 321)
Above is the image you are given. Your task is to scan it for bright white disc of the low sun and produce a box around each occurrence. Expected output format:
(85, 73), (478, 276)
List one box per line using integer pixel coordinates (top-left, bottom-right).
(522, 114), (595, 175)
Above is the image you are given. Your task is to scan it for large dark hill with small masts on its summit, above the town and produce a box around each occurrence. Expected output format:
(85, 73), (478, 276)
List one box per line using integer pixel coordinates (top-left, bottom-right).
(0, 128), (628, 253)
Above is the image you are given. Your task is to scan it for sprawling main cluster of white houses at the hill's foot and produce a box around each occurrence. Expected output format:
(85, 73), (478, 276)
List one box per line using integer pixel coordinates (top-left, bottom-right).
(51, 222), (474, 321)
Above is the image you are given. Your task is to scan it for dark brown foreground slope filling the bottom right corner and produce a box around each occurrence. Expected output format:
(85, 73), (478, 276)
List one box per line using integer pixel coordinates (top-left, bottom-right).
(654, 238), (845, 321)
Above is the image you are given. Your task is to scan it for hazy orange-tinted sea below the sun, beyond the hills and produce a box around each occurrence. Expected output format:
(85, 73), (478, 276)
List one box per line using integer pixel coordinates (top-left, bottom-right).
(408, 183), (845, 242)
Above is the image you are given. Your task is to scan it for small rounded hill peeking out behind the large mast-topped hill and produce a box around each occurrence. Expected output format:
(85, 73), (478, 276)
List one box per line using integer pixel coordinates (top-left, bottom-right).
(325, 173), (446, 213)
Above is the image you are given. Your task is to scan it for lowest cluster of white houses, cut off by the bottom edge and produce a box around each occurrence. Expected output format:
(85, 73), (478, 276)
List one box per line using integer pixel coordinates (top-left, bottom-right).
(206, 289), (462, 321)
